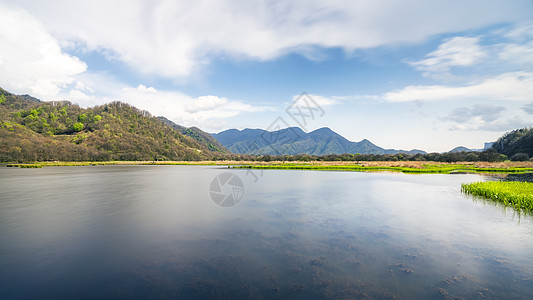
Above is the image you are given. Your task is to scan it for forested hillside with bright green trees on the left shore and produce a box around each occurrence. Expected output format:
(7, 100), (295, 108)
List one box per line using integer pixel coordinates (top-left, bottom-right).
(0, 89), (227, 162)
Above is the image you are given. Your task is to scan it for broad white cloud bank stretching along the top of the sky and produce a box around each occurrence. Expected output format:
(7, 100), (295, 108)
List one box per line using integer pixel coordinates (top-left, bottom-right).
(6, 0), (533, 78)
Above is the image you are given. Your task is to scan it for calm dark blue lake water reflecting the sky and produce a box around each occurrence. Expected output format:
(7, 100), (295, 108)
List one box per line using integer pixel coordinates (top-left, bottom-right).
(0, 166), (533, 299)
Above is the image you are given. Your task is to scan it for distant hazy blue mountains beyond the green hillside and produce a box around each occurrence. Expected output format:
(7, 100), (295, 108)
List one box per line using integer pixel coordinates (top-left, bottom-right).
(212, 127), (426, 155)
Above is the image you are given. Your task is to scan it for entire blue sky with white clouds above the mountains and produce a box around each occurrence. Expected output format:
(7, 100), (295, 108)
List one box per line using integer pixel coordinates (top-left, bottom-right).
(0, 0), (533, 152)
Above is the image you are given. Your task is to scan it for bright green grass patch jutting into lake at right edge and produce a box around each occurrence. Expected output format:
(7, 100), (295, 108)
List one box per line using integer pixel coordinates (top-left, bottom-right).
(461, 181), (533, 213)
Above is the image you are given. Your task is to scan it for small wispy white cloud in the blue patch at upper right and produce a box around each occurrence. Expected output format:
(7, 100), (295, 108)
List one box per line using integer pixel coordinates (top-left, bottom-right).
(408, 37), (487, 76)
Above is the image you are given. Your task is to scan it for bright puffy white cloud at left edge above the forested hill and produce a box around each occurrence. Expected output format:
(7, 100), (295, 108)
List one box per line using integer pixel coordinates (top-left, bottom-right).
(0, 3), (87, 100)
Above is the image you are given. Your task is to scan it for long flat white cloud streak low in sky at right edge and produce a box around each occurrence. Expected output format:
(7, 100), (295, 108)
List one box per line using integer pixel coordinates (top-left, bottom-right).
(383, 72), (533, 102)
